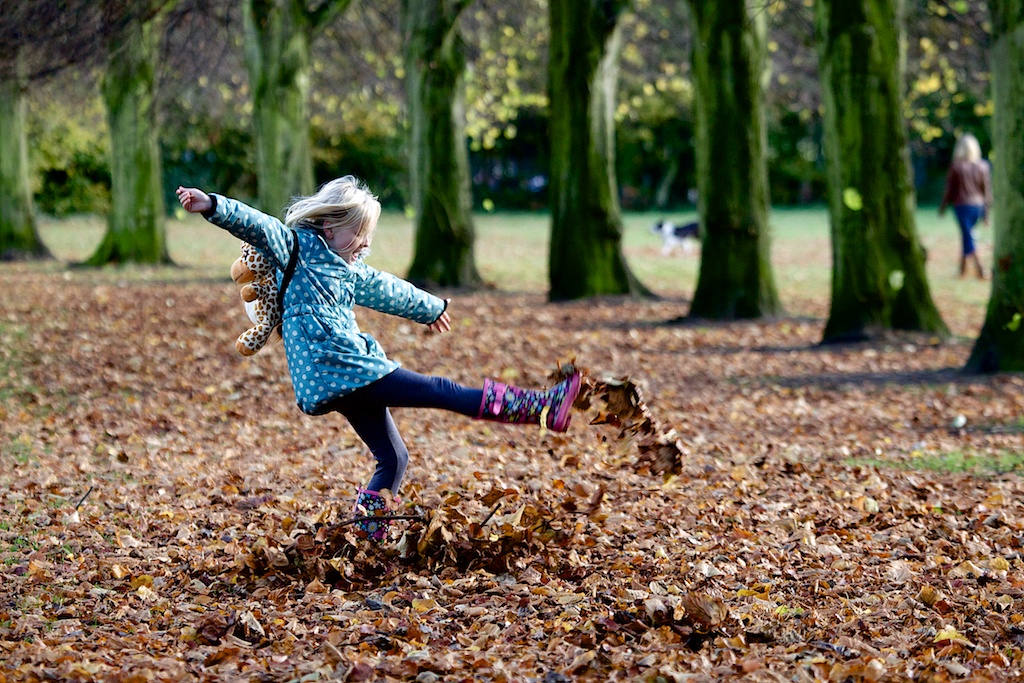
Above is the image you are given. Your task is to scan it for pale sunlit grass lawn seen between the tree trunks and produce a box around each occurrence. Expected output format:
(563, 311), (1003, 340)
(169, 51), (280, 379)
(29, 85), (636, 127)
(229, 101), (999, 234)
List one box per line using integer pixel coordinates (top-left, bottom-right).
(34, 207), (991, 336)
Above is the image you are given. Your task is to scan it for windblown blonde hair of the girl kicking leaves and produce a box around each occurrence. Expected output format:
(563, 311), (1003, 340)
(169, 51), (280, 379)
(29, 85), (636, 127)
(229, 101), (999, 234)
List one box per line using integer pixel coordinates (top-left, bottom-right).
(285, 175), (381, 260)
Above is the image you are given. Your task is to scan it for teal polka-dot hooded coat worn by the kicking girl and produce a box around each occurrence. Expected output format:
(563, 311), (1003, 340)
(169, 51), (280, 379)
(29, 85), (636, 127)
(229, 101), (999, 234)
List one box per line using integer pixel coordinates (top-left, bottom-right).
(203, 195), (446, 415)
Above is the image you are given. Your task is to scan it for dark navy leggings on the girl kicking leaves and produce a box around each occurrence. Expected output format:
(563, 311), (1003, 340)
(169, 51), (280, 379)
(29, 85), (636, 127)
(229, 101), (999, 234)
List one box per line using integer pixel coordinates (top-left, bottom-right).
(328, 368), (483, 494)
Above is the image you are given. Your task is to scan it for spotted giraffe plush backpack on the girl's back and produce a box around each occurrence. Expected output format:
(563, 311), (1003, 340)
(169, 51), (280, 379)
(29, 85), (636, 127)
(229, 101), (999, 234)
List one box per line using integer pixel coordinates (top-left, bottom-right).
(231, 242), (281, 355)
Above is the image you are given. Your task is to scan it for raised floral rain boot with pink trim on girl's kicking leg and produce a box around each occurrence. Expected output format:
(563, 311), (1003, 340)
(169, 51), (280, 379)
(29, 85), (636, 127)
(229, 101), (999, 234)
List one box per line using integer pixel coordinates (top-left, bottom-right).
(476, 373), (580, 432)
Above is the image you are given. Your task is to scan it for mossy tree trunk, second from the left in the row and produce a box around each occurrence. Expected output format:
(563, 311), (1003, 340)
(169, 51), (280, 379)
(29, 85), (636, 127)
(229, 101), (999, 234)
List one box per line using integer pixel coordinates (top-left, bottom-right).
(86, 7), (171, 266)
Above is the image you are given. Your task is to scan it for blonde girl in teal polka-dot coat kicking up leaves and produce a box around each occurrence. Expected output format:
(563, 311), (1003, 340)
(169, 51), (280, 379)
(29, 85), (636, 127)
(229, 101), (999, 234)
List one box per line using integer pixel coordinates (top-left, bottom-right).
(177, 175), (580, 541)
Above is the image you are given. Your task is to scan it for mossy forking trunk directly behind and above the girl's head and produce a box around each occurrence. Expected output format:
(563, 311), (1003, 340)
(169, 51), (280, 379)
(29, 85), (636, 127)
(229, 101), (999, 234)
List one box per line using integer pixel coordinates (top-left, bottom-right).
(243, 0), (351, 215)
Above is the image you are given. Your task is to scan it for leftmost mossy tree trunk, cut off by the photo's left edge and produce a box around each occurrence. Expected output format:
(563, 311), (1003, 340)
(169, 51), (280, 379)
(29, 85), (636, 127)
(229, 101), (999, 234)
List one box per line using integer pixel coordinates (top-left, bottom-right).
(0, 56), (50, 261)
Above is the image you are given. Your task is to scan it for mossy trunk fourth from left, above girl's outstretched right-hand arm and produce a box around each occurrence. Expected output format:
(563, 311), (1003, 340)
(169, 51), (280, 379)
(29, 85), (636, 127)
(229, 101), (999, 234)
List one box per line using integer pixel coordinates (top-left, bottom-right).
(401, 0), (481, 288)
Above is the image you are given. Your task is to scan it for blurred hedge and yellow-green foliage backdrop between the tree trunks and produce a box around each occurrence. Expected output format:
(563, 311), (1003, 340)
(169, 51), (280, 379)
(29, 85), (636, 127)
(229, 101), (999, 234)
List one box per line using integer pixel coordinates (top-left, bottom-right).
(22, 0), (992, 216)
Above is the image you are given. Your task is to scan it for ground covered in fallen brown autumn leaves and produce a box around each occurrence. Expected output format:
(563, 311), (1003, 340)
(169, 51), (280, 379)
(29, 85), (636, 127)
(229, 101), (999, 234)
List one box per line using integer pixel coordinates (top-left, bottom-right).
(0, 265), (1024, 683)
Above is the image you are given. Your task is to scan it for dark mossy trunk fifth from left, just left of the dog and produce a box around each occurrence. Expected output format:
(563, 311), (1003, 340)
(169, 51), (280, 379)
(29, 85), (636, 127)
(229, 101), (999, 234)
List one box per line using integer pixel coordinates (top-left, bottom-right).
(548, 0), (649, 301)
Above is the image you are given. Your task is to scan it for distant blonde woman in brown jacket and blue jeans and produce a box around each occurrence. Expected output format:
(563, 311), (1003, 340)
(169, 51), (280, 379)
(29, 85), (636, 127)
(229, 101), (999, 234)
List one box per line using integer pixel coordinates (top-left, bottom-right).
(939, 133), (992, 280)
